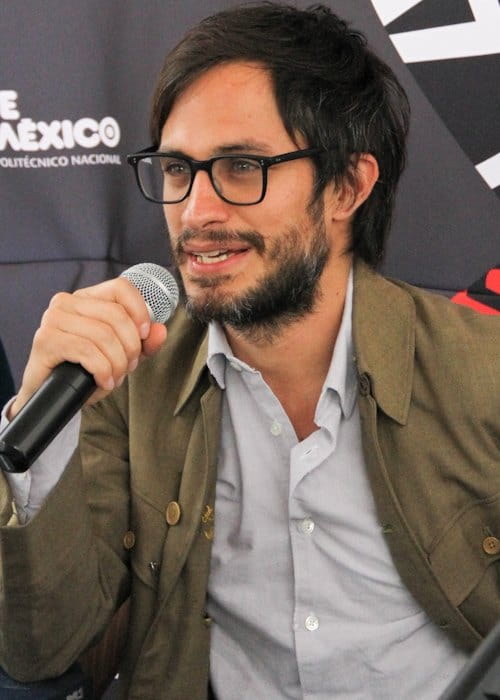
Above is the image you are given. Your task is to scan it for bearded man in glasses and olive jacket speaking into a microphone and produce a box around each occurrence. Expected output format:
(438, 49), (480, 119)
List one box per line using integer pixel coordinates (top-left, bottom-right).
(0, 3), (500, 699)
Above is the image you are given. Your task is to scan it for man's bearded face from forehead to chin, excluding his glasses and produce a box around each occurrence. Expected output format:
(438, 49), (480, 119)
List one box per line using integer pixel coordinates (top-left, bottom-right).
(160, 63), (348, 328)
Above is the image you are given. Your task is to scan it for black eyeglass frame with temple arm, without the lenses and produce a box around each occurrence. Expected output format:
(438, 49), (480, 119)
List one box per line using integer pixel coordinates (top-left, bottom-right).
(127, 146), (320, 207)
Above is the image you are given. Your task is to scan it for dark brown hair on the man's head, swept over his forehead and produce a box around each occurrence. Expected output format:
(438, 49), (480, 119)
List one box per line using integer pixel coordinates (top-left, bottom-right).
(151, 2), (410, 267)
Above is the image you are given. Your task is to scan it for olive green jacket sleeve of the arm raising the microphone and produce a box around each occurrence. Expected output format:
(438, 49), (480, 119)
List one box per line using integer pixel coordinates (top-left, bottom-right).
(0, 388), (130, 681)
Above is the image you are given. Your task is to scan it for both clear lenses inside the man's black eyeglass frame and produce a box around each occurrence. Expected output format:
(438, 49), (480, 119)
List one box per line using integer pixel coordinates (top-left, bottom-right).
(138, 156), (263, 204)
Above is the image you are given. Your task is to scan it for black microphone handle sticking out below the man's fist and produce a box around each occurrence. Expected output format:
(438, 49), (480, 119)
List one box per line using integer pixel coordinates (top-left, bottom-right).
(0, 362), (96, 472)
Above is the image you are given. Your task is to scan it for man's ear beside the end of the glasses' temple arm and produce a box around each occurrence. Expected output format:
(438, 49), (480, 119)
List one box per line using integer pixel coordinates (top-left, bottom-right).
(332, 153), (379, 221)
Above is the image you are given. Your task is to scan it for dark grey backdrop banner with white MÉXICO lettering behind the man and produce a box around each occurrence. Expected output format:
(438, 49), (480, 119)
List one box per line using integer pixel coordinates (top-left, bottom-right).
(0, 0), (500, 384)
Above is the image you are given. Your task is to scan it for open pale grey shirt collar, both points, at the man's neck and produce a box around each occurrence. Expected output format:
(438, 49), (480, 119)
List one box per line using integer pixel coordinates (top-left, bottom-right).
(207, 268), (357, 417)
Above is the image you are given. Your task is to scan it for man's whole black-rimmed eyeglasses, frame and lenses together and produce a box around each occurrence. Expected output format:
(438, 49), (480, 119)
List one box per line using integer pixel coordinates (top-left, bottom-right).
(127, 148), (323, 206)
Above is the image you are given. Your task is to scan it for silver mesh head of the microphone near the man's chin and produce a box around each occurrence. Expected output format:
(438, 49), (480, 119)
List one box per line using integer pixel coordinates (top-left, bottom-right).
(120, 263), (179, 323)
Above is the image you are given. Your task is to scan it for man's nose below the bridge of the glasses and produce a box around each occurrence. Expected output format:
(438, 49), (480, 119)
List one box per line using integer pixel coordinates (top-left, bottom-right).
(181, 171), (230, 229)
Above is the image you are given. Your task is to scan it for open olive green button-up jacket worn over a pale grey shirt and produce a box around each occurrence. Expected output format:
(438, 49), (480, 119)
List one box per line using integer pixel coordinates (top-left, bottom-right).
(0, 263), (500, 700)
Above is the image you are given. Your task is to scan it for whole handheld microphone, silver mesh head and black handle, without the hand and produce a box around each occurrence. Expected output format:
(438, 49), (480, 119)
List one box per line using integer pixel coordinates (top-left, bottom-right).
(0, 263), (179, 472)
